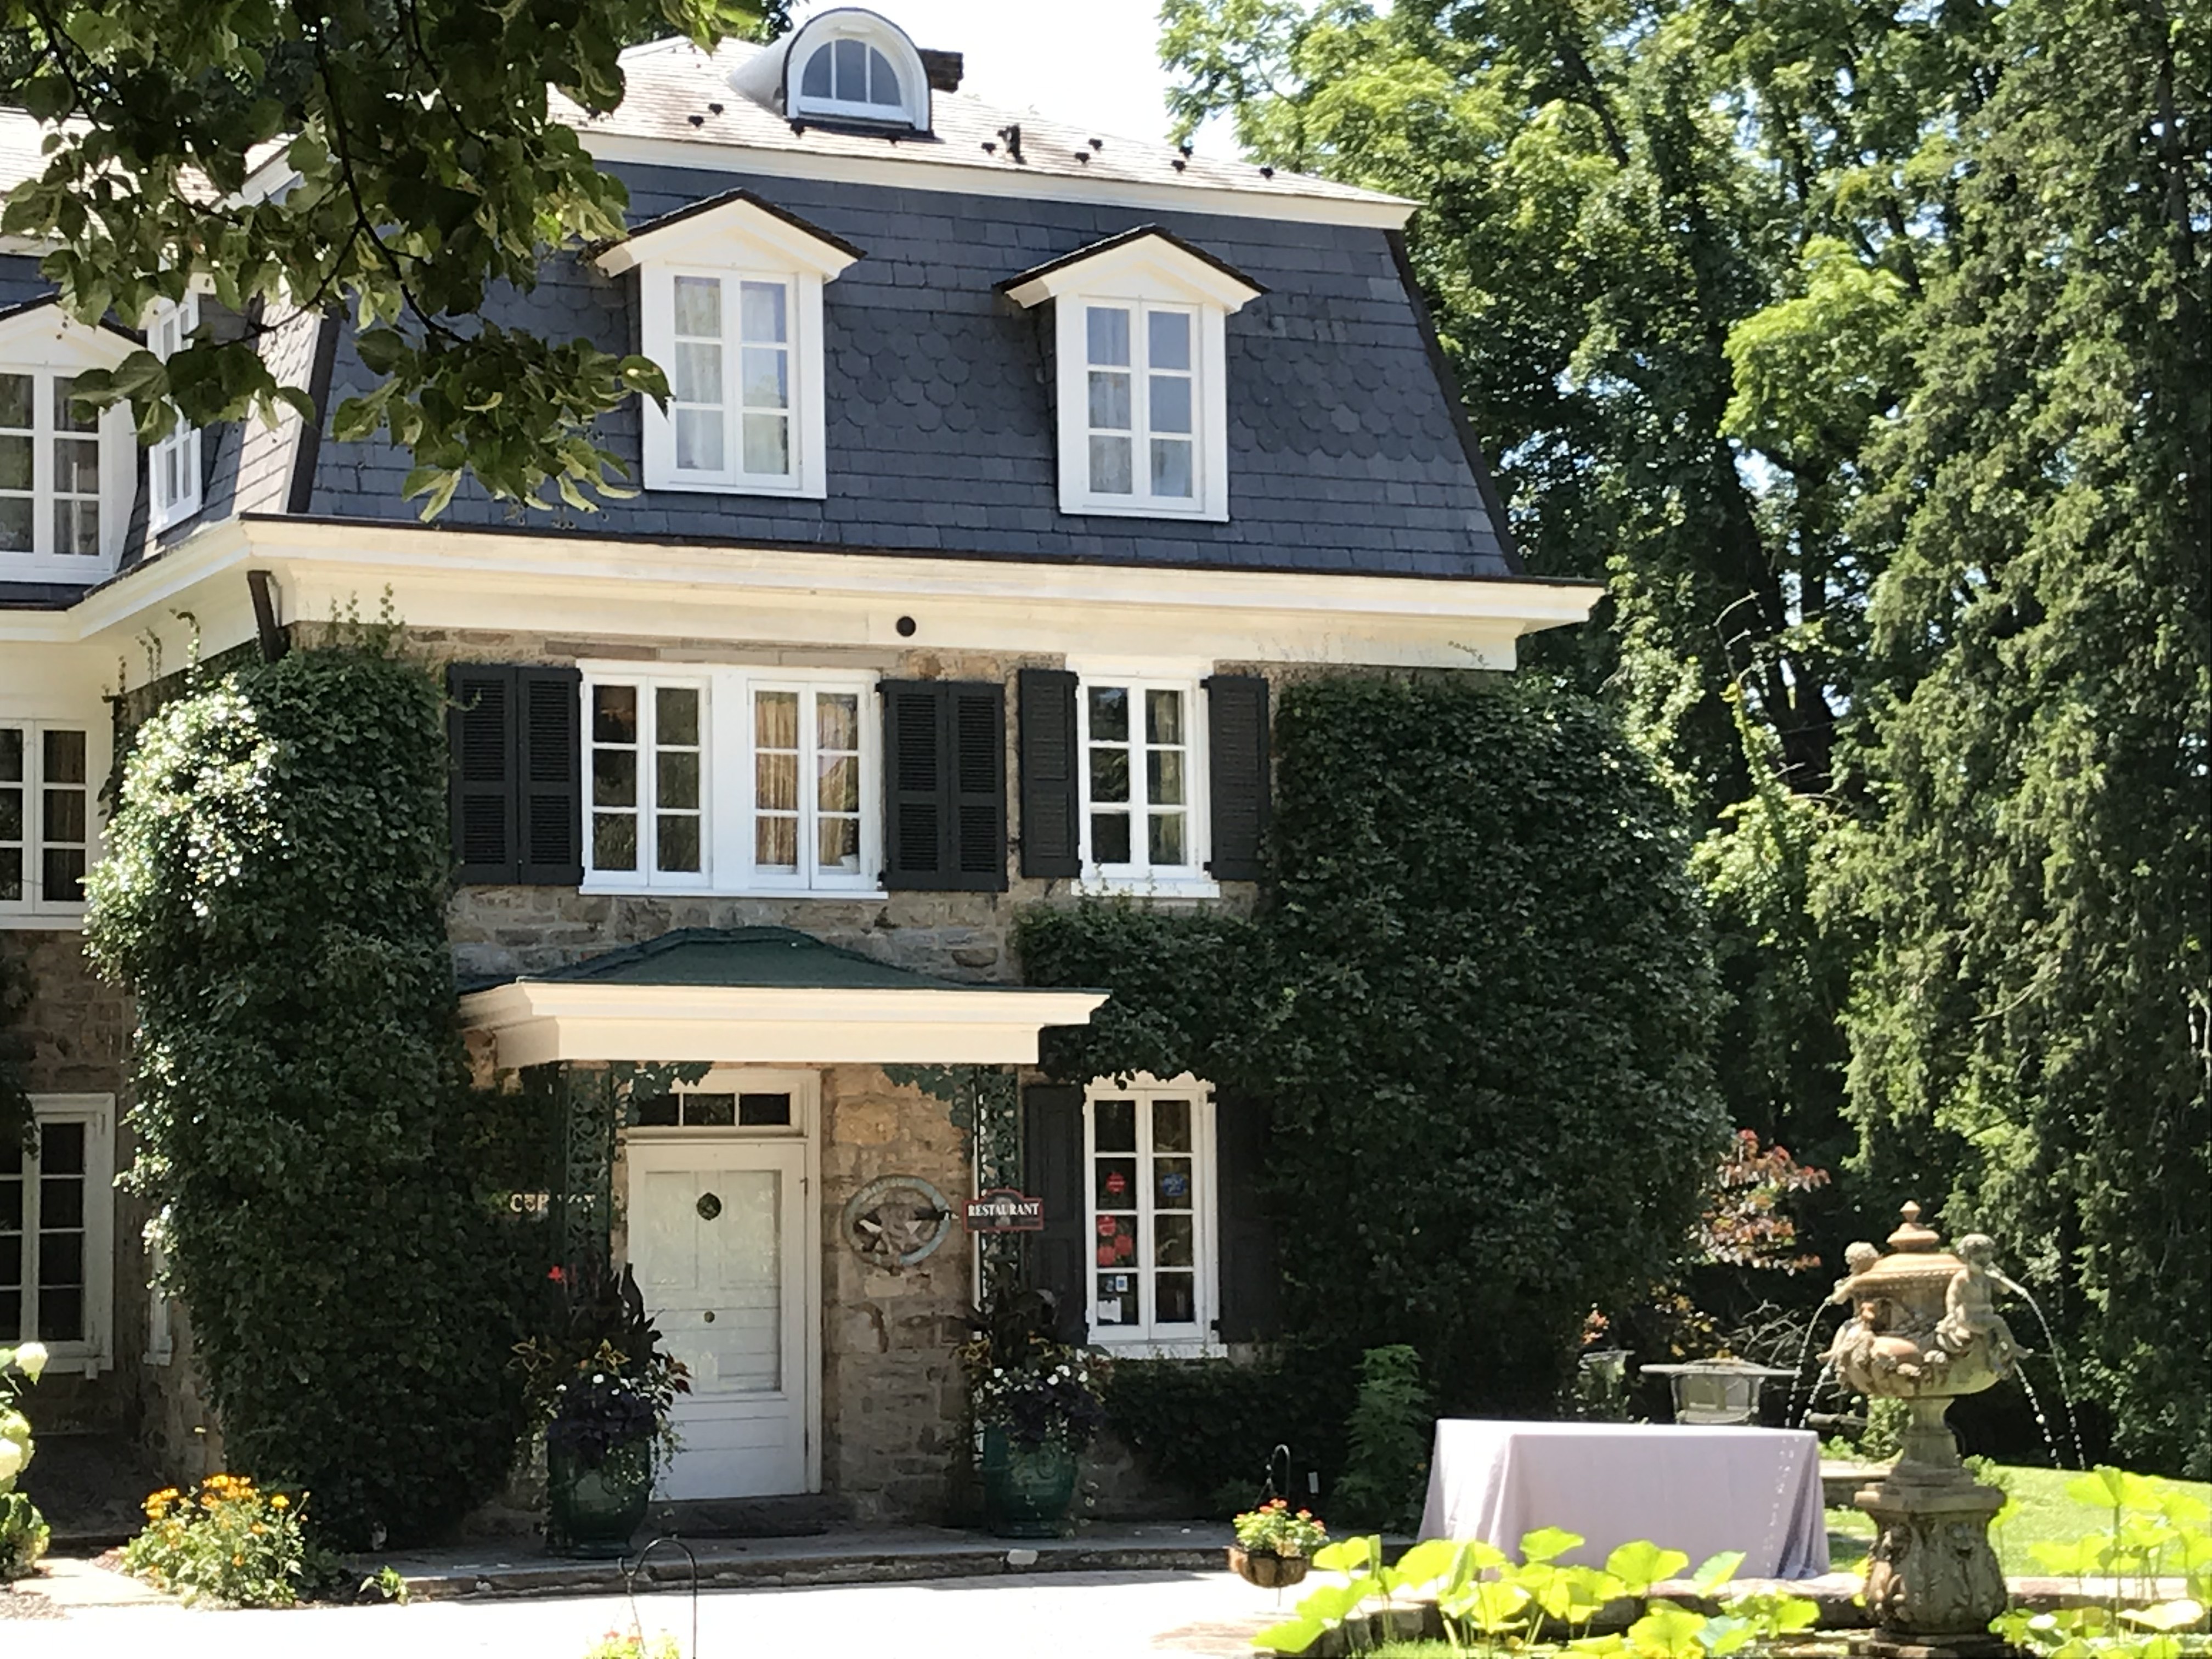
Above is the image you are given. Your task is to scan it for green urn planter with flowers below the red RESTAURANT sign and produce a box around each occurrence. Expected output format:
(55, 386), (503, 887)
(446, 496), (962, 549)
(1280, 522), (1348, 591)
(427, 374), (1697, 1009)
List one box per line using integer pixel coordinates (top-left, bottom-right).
(960, 1292), (1108, 1537)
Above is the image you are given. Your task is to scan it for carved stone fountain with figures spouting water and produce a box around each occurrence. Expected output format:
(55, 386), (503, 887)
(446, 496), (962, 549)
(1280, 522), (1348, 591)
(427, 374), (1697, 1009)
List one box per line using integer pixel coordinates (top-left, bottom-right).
(1825, 1203), (2026, 1659)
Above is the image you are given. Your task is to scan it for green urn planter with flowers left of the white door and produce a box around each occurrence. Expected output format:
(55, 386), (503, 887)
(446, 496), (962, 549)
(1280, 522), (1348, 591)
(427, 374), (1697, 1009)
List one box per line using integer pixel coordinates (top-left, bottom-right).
(515, 1267), (690, 1558)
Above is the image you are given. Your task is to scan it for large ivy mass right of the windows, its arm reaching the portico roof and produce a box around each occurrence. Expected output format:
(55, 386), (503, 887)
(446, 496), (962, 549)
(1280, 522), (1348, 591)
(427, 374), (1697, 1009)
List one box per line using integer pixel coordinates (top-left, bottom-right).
(1020, 677), (1725, 1455)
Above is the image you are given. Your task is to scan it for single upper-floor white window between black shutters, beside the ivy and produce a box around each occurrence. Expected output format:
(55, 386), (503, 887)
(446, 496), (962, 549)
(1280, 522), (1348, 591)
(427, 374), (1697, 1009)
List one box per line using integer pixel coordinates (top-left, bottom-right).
(1075, 668), (1215, 896)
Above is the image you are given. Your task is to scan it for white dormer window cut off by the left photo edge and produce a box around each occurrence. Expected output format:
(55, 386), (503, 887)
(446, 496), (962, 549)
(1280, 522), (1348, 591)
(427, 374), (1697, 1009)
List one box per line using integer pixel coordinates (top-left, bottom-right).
(0, 303), (137, 582)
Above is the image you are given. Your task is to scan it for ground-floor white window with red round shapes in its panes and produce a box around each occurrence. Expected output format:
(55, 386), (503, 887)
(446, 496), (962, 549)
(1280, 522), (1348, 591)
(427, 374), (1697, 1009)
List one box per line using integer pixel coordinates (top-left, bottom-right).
(1084, 1077), (1217, 1342)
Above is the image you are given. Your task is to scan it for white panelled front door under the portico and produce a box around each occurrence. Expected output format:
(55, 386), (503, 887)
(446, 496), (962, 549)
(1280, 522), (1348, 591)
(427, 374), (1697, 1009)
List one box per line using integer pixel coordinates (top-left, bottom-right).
(630, 1139), (814, 1498)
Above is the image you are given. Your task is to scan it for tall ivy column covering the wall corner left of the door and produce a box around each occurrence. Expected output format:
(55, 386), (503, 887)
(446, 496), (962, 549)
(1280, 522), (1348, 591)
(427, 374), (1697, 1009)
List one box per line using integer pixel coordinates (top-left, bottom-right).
(86, 641), (522, 1542)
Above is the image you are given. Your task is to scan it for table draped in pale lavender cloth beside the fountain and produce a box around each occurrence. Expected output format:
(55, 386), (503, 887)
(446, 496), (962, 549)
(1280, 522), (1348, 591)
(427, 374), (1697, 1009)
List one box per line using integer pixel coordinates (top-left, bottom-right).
(1420, 1418), (1827, 1579)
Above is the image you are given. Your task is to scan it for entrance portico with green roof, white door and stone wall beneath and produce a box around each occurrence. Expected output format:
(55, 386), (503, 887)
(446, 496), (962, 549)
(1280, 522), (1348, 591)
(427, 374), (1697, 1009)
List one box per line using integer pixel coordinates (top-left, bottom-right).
(462, 927), (1106, 1500)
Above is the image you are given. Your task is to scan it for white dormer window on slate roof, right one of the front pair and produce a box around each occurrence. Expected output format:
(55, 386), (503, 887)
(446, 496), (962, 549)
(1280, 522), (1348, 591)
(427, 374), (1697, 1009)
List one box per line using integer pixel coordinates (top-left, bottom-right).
(1000, 228), (1265, 520)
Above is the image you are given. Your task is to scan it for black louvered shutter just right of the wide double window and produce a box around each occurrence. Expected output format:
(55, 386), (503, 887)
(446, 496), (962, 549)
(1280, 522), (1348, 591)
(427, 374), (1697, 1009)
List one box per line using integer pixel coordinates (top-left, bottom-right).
(878, 679), (1007, 891)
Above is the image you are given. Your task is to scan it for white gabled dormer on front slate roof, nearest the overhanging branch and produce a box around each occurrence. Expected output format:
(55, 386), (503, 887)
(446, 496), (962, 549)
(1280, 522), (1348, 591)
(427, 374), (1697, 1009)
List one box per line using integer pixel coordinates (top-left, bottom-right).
(597, 190), (860, 500)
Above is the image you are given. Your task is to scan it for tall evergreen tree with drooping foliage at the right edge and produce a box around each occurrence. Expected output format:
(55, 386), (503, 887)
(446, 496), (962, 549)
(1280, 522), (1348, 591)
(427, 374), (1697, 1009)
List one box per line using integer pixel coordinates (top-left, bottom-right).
(1847, 0), (2212, 1475)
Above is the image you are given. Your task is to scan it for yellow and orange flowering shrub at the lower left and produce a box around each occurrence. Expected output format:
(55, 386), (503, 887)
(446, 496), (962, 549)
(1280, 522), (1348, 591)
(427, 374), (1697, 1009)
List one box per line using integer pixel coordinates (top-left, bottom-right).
(124, 1475), (307, 1608)
